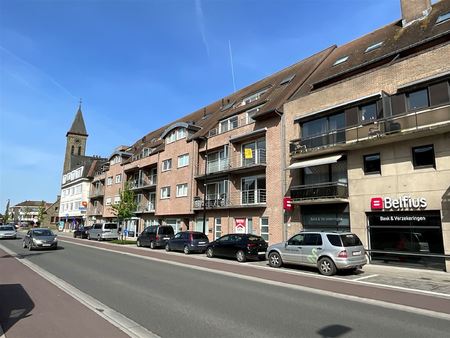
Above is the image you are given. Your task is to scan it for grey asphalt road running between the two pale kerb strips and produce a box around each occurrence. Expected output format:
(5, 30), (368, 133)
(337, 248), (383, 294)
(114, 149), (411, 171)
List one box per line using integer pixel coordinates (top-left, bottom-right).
(0, 240), (450, 338)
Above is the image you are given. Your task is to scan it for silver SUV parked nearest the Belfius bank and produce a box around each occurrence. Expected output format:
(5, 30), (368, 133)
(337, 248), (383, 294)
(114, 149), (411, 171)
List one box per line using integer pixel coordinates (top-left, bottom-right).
(266, 231), (367, 276)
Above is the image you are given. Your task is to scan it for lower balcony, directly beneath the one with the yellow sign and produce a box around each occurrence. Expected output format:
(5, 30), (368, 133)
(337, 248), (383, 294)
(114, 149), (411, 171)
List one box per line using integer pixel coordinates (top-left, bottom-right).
(193, 189), (266, 210)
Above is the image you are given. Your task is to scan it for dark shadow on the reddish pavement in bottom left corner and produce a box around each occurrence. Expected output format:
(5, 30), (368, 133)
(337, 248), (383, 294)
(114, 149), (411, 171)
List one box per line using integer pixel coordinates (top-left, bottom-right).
(0, 284), (34, 334)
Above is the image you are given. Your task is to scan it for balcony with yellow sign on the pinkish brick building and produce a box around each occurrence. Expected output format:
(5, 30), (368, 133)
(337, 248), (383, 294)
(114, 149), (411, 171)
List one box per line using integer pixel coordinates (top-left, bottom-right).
(195, 149), (267, 179)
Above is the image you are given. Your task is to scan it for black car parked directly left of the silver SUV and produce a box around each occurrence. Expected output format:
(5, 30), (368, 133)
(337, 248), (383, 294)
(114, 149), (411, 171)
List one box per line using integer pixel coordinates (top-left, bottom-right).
(206, 234), (267, 262)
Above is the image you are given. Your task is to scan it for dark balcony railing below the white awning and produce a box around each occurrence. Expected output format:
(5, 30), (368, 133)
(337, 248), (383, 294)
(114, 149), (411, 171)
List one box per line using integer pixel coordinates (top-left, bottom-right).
(291, 182), (348, 201)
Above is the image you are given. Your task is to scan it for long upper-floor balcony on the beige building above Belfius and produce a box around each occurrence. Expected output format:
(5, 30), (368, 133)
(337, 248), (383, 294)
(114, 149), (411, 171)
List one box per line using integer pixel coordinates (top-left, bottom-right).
(289, 105), (450, 158)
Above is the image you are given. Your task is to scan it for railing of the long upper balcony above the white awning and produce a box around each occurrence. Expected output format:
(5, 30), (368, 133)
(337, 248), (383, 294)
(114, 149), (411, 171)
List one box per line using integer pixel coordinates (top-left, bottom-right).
(289, 106), (450, 156)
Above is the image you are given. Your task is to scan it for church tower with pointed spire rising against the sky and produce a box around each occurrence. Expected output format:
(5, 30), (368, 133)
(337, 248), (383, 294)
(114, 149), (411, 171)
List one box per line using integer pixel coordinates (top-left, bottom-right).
(63, 103), (88, 173)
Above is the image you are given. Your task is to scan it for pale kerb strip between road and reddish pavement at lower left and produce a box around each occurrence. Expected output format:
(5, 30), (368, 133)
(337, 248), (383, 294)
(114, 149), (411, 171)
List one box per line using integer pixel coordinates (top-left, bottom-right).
(0, 244), (160, 338)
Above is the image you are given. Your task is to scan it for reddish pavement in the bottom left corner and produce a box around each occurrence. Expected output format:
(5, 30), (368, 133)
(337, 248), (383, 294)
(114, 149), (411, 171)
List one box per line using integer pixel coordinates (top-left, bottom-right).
(0, 249), (128, 338)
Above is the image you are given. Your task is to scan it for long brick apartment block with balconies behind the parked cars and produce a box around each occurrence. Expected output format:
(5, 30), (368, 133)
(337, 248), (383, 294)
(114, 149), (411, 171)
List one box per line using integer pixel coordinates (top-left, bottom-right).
(79, 0), (450, 271)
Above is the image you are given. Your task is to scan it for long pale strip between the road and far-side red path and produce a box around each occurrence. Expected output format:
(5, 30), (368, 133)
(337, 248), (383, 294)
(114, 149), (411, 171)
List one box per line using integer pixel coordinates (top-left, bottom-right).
(53, 241), (450, 320)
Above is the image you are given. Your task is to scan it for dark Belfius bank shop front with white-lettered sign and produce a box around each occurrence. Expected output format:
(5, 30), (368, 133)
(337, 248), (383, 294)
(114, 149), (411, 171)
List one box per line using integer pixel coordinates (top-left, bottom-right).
(366, 196), (445, 270)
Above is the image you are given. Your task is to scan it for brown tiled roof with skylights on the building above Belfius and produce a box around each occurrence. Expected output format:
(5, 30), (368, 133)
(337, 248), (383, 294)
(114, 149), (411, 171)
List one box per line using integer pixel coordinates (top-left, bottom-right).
(292, 0), (450, 100)
